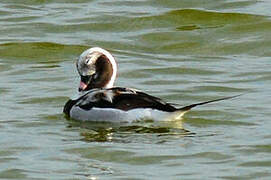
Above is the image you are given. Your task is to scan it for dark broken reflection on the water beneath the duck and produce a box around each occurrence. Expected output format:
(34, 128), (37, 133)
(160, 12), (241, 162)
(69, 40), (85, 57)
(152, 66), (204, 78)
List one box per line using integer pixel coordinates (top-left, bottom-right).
(68, 120), (194, 142)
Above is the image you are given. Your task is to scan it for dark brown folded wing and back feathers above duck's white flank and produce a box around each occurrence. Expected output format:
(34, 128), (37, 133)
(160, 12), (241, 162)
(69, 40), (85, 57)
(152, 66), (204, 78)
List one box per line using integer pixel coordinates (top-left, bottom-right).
(76, 87), (176, 112)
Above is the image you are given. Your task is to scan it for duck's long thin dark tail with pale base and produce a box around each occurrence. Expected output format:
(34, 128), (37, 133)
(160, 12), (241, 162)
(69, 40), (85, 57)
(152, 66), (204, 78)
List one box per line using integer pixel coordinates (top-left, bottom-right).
(174, 94), (242, 119)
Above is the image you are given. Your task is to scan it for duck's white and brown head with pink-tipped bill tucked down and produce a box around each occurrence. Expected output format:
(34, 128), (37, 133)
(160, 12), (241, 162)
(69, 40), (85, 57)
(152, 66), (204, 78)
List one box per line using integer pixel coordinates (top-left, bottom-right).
(76, 47), (117, 91)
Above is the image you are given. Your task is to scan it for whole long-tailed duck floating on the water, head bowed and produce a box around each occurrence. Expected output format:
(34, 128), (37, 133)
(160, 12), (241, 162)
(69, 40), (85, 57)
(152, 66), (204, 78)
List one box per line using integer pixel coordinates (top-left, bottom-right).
(63, 47), (239, 122)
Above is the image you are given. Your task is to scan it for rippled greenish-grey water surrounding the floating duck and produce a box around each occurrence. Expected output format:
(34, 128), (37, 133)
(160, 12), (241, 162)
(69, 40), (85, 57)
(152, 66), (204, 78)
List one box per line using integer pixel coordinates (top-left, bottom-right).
(0, 0), (271, 180)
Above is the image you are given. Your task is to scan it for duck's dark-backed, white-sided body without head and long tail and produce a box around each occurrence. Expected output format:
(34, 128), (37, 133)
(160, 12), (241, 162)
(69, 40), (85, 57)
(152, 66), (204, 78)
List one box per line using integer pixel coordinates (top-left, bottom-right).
(64, 87), (185, 122)
